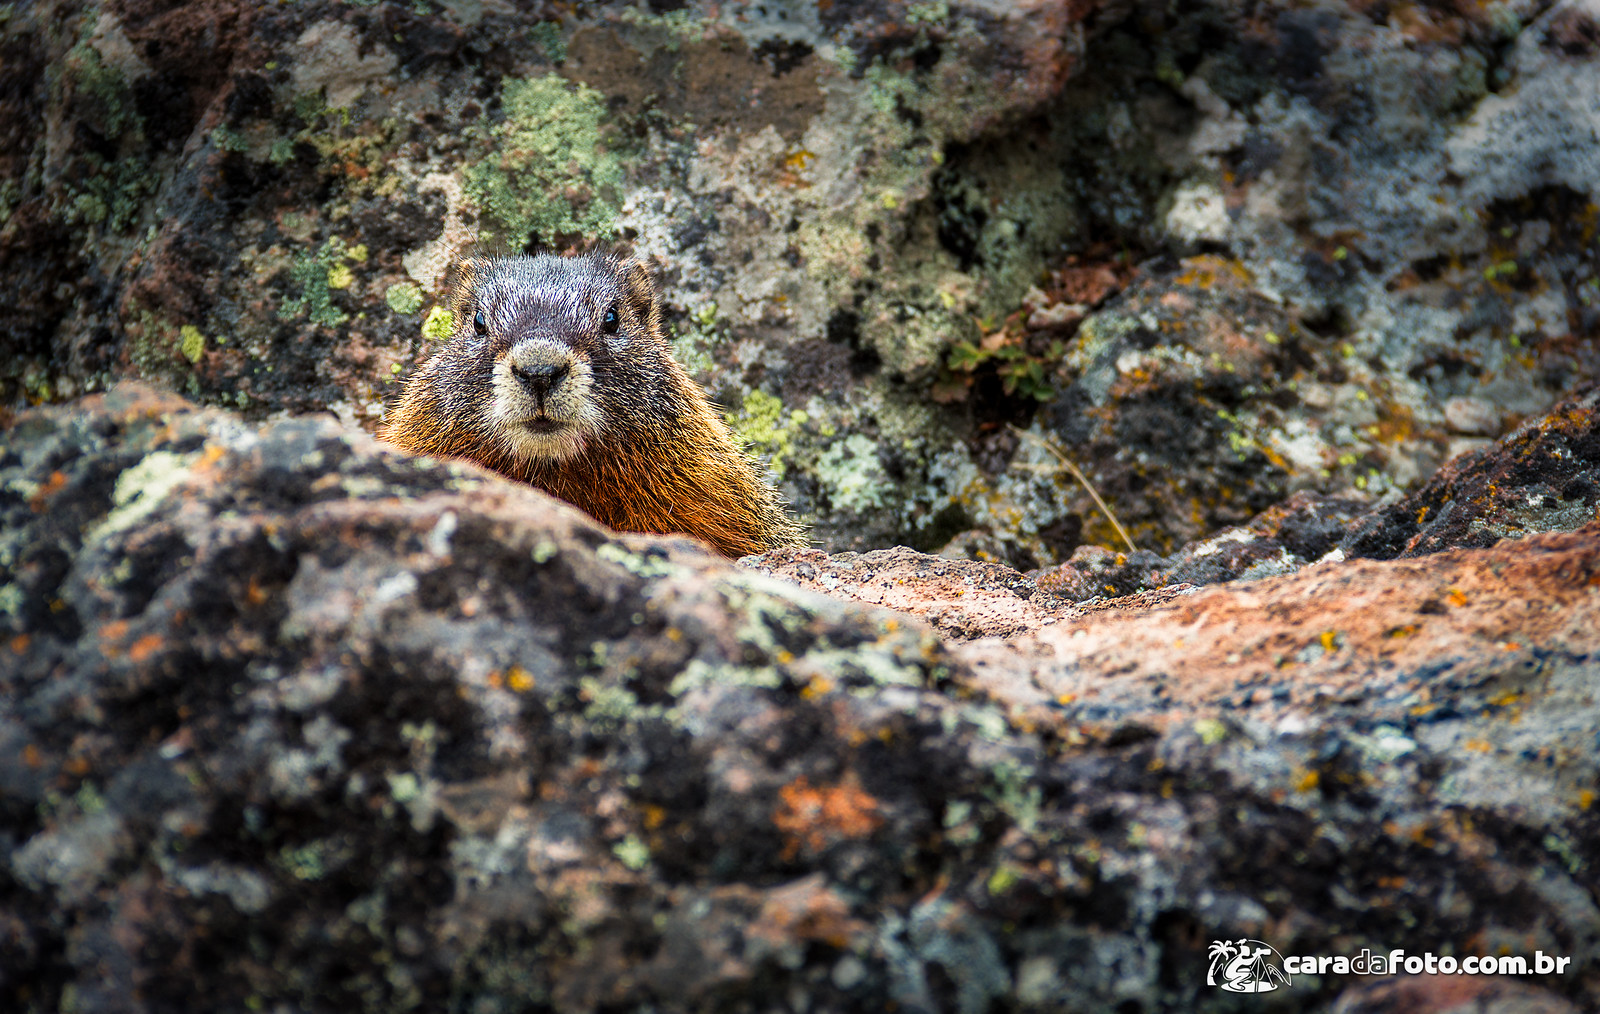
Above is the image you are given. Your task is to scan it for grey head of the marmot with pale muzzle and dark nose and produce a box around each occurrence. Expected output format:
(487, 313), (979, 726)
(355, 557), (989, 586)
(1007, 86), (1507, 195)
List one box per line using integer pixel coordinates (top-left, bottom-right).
(446, 254), (670, 462)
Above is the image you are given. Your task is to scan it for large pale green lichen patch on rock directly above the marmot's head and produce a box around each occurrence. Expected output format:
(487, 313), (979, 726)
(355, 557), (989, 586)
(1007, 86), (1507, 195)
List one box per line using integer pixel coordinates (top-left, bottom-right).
(466, 74), (622, 246)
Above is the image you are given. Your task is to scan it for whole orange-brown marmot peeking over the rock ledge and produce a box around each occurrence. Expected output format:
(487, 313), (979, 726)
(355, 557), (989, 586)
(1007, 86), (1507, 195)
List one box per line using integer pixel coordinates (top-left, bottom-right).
(379, 253), (805, 557)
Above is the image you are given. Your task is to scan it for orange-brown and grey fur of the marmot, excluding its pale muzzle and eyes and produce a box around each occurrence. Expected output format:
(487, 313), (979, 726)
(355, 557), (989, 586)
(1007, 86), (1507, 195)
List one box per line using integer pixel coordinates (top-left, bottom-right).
(372, 254), (803, 557)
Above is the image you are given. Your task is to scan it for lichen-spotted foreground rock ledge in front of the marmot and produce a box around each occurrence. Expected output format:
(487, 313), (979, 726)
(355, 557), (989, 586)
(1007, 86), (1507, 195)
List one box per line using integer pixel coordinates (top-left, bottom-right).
(0, 385), (1600, 1014)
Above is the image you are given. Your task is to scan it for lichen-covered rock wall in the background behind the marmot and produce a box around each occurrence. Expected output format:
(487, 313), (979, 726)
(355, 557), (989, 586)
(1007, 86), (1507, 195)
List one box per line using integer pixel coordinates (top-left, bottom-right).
(0, 0), (1600, 569)
